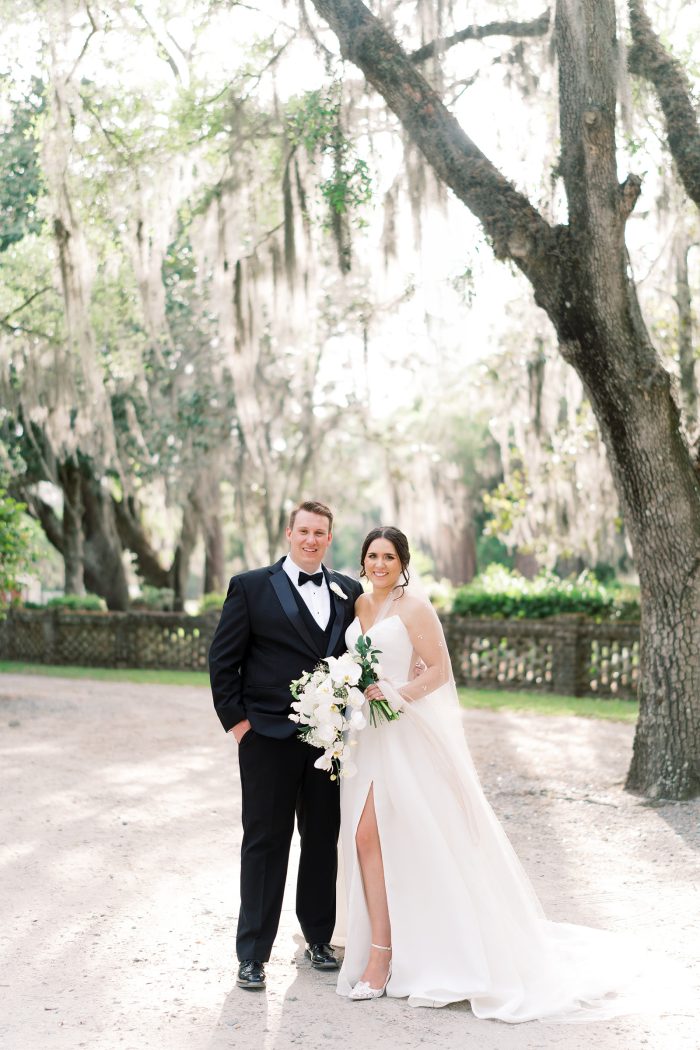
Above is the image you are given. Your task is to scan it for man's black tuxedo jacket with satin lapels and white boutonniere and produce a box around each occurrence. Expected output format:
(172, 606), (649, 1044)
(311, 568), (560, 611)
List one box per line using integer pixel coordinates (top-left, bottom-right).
(209, 558), (362, 737)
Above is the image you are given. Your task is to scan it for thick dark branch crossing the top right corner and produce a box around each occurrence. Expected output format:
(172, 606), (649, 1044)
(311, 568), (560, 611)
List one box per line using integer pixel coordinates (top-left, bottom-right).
(628, 0), (700, 208)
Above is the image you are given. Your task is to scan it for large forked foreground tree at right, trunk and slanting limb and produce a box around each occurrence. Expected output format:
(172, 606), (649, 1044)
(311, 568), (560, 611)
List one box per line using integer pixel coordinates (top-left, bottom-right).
(313, 0), (700, 799)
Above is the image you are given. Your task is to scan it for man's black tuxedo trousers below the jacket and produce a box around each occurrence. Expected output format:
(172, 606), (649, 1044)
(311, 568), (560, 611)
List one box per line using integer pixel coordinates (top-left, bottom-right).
(236, 730), (340, 962)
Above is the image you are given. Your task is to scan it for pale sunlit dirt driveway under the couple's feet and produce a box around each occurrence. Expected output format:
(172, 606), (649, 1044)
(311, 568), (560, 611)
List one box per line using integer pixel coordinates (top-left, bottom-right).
(0, 675), (700, 1050)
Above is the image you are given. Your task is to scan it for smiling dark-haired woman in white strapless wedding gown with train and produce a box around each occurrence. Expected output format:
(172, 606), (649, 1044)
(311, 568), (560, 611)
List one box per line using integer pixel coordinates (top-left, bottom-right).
(337, 526), (659, 1022)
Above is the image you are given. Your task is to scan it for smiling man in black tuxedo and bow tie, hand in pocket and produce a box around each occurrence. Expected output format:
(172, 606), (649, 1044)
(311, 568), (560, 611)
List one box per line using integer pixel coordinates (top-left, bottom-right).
(209, 502), (362, 988)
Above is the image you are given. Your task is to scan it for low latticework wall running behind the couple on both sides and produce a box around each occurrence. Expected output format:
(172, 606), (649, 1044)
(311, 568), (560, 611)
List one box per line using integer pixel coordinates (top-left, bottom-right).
(0, 609), (639, 697)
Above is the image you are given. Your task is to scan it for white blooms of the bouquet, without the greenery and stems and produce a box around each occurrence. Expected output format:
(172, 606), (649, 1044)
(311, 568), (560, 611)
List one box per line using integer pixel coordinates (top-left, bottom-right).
(290, 652), (367, 780)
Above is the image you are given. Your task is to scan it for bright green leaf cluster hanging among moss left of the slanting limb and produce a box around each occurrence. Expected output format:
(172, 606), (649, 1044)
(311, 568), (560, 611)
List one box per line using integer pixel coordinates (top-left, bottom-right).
(288, 82), (372, 226)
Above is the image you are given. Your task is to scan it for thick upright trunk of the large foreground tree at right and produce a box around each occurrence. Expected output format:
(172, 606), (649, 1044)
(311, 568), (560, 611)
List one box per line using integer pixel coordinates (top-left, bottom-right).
(550, 0), (700, 798)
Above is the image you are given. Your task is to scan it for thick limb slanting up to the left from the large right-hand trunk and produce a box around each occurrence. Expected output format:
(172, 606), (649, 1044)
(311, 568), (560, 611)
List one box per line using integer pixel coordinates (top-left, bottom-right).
(313, 0), (556, 295)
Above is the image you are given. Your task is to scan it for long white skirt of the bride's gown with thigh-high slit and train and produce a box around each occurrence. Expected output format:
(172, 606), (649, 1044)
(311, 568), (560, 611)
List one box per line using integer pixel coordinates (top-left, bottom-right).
(337, 686), (663, 1022)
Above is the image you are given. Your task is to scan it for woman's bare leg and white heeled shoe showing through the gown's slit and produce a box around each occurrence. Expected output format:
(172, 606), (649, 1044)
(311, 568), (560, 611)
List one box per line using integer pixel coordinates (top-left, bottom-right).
(355, 784), (391, 988)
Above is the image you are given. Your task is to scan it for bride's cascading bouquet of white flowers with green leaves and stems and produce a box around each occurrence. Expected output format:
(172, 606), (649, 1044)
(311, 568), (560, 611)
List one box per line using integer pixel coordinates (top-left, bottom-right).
(290, 635), (400, 780)
